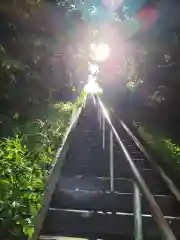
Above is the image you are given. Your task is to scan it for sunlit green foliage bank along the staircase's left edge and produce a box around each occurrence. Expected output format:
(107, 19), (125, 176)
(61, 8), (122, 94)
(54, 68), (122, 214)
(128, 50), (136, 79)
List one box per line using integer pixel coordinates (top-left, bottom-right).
(0, 102), (73, 240)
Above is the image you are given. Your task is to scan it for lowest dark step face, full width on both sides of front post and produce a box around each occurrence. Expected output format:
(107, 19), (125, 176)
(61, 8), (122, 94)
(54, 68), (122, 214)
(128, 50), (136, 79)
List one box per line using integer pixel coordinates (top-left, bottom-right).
(41, 208), (180, 239)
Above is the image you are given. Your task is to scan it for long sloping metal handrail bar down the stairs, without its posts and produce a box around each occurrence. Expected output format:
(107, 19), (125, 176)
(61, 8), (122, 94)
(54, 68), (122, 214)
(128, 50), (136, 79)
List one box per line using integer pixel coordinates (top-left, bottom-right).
(96, 95), (176, 240)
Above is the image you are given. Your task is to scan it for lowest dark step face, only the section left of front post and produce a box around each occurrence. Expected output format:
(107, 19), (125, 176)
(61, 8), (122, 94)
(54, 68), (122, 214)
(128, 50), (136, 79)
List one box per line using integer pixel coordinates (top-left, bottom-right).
(41, 209), (133, 239)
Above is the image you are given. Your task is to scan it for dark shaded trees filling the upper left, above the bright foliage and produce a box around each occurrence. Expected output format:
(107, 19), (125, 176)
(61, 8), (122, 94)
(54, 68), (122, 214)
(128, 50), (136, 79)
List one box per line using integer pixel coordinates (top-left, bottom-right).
(0, 0), (73, 131)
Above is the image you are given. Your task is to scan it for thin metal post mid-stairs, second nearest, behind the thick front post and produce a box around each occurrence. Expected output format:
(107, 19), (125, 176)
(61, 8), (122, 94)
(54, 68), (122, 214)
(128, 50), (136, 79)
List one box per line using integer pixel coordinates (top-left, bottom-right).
(109, 130), (114, 192)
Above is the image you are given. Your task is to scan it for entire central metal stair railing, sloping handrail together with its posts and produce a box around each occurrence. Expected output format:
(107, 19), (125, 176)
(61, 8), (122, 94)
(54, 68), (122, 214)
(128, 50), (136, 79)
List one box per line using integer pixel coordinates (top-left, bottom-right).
(93, 95), (176, 240)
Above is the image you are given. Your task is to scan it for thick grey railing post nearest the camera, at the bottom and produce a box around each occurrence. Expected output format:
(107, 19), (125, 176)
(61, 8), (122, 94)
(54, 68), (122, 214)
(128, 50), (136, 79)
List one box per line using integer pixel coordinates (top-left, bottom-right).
(133, 182), (143, 240)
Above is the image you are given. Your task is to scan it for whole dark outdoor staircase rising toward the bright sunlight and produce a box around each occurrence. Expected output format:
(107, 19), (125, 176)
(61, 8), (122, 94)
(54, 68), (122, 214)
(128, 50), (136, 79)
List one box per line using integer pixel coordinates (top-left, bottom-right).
(39, 95), (180, 240)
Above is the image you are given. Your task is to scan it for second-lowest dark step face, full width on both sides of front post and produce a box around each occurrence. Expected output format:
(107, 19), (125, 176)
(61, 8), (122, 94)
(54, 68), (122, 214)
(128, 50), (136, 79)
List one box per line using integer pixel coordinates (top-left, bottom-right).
(50, 189), (180, 217)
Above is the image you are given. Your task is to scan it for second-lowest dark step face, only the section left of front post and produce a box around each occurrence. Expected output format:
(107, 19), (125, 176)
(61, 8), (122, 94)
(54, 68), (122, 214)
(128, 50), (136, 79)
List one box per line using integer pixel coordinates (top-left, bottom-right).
(50, 189), (133, 213)
